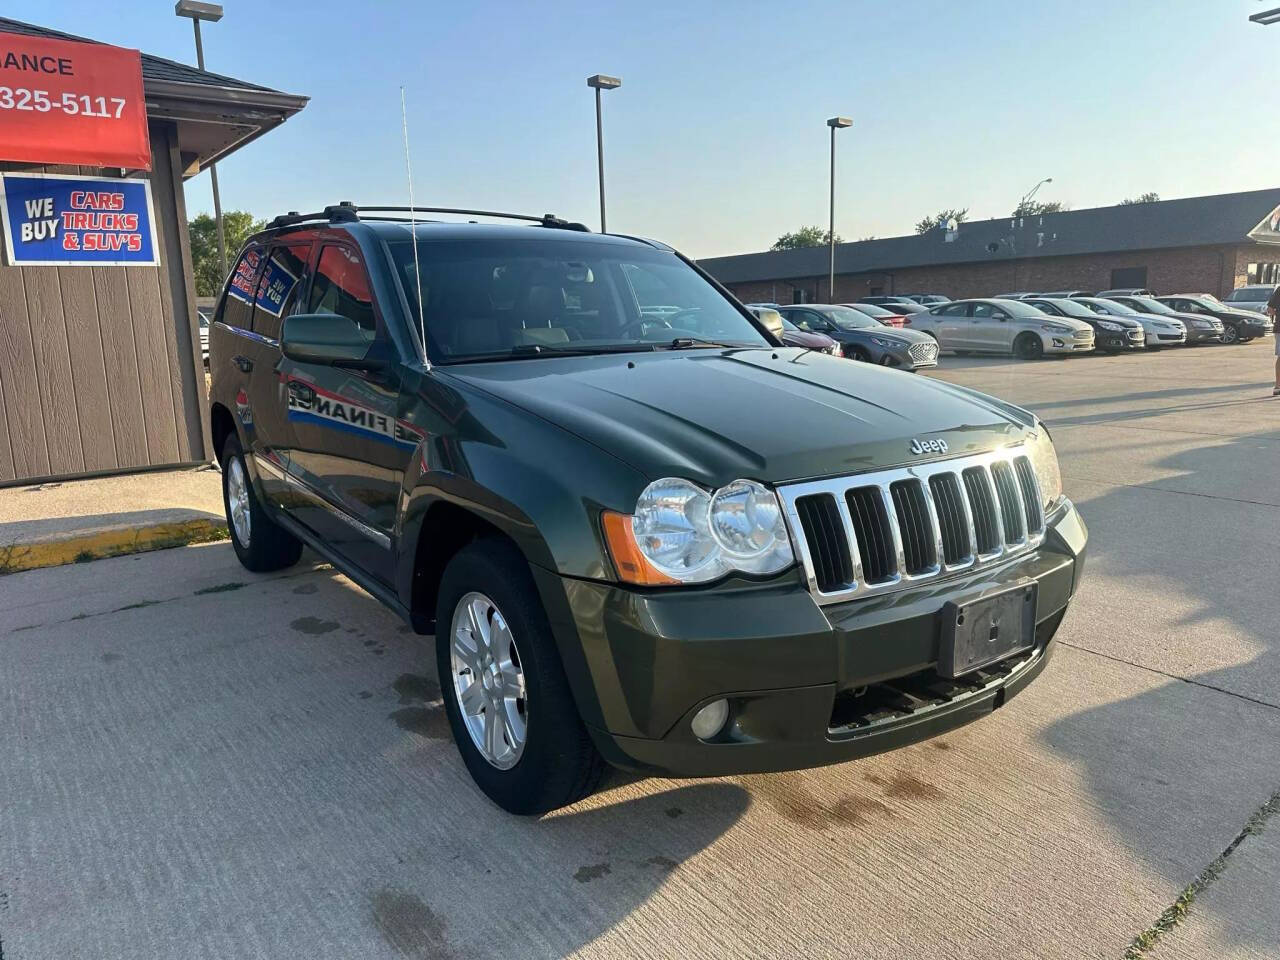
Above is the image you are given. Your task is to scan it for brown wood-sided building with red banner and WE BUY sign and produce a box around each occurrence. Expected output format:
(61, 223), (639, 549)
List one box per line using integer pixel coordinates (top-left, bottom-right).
(0, 17), (307, 486)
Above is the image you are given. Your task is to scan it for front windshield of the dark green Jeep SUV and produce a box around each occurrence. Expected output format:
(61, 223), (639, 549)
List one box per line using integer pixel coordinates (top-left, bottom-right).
(388, 239), (768, 364)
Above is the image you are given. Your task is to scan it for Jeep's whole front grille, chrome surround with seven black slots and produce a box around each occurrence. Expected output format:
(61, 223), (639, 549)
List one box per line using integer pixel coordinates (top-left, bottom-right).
(778, 447), (1044, 603)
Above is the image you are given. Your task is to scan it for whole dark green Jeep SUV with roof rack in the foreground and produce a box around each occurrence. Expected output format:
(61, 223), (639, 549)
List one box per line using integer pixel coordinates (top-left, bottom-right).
(210, 204), (1087, 814)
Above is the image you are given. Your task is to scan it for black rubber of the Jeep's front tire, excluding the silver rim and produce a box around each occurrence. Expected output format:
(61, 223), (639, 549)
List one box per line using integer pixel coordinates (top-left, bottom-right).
(435, 539), (608, 815)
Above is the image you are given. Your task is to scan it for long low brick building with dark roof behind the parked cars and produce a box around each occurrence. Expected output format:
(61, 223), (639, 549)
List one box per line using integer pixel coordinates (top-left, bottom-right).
(699, 188), (1280, 303)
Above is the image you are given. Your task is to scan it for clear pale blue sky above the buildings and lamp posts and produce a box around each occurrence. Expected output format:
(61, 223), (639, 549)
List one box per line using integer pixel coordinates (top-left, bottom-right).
(4, 0), (1280, 257)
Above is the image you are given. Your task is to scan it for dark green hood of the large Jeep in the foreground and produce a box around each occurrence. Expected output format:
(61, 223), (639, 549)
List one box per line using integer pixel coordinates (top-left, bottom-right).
(438, 347), (1033, 486)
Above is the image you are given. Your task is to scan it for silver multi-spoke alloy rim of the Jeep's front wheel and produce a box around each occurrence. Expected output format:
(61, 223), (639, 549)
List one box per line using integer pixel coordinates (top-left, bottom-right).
(449, 591), (529, 771)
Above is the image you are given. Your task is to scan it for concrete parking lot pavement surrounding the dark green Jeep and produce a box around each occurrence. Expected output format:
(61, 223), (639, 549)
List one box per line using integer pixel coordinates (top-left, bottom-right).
(0, 340), (1280, 960)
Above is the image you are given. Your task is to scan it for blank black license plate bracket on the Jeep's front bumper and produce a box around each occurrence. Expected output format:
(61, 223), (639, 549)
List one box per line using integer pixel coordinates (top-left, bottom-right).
(938, 580), (1037, 680)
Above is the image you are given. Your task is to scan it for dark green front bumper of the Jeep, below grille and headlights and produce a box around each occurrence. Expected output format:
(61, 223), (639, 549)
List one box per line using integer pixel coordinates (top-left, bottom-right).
(539, 500), (1088, 777)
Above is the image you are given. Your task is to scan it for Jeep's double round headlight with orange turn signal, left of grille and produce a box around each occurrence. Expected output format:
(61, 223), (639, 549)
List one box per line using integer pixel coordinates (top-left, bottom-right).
(604, 477), (795, 586)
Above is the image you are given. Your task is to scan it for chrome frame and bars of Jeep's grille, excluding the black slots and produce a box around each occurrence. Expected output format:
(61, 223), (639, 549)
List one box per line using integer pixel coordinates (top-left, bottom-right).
(777, 443), (1048, 604)
